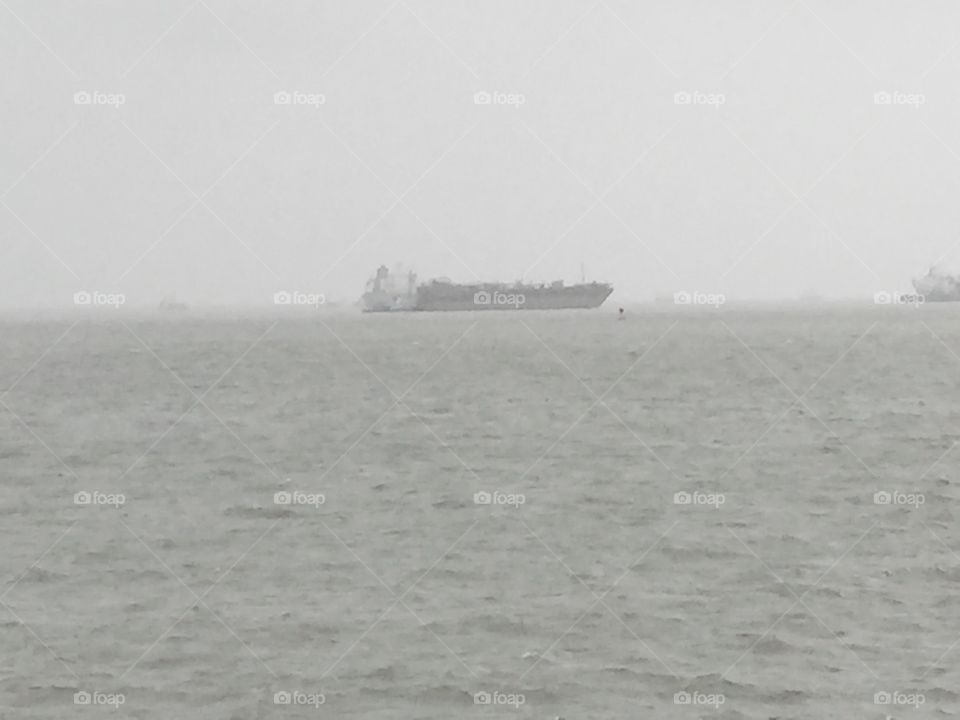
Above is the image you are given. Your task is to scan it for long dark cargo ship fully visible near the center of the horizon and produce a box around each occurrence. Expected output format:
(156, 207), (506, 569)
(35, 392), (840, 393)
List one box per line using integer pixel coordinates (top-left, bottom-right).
(362, 265), (613, 312)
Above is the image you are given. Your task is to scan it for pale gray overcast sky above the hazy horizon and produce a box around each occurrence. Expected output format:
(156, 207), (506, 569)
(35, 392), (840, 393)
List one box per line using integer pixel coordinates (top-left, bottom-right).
(0, 0), (960, 307)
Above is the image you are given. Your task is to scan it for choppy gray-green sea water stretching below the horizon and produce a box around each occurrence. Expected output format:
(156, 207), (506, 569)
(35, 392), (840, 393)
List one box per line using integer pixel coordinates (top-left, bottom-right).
(0, 305), (960, 720)
